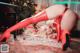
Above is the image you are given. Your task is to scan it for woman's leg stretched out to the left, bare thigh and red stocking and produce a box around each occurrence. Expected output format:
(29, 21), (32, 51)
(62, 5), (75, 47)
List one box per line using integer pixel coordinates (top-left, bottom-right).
(1, 5), (65, 40)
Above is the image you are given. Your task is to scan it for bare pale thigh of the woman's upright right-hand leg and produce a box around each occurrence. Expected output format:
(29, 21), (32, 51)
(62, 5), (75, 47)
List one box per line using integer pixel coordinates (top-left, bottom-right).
(61, 10), (76, 31)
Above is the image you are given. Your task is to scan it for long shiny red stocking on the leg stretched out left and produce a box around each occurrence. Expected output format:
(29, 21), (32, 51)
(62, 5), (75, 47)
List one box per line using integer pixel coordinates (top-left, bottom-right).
(0, 11), (48, 41)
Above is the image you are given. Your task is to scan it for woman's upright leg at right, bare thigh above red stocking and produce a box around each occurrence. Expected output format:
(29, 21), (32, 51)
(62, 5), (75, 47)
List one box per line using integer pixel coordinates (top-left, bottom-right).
(60, 9), (76, 49)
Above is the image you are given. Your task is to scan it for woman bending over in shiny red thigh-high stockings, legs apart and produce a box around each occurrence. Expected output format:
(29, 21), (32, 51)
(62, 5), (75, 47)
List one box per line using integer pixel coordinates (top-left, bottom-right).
(0, 5), (76, 49)
